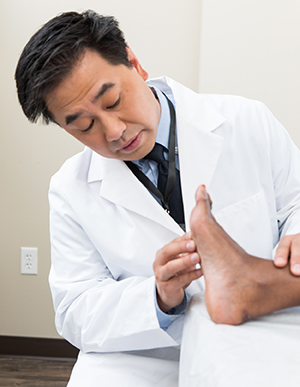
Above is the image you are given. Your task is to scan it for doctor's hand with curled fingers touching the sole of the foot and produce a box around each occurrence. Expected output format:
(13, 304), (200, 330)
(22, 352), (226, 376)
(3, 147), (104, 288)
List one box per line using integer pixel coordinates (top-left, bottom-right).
(153, 233), (202, 312)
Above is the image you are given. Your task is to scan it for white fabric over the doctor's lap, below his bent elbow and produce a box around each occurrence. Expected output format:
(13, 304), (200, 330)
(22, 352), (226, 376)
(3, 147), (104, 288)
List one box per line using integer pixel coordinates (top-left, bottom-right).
(68, 348), (179, 387)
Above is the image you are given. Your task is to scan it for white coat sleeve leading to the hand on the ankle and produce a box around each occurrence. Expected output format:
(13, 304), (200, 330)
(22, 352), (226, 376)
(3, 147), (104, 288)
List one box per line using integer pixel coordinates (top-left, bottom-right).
(261, 104), (300, 244)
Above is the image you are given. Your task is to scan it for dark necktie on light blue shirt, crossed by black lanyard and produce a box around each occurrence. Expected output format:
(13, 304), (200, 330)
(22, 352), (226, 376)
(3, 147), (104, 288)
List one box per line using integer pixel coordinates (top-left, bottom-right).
(144, 143), (184, 228)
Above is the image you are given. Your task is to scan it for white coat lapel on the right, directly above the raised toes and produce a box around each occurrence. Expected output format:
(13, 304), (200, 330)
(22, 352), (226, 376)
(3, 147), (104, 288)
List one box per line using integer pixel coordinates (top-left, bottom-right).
(167, 80), (225, 231)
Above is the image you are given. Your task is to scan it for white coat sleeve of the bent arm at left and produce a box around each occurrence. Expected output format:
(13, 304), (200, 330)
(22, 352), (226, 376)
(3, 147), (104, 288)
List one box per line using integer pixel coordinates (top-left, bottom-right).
(49, 176), (178, 352)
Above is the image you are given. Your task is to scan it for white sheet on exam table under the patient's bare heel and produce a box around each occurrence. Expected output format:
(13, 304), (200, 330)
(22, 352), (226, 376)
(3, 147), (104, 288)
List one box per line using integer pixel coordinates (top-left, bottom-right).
(179, 294), (300, 387)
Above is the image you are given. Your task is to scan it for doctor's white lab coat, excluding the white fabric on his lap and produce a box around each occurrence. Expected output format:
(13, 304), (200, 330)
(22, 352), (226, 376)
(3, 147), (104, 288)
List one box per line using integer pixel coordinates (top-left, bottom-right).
(49, 78), (300, 386)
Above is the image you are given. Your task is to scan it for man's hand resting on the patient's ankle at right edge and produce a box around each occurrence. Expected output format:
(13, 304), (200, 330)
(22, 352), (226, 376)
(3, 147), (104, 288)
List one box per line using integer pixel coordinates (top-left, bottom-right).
(274, 234), (300, 276)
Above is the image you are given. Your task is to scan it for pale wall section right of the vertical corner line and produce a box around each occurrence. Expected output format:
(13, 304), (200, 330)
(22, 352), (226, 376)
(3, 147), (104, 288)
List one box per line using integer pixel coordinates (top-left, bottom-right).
(199, 0), (300, 147)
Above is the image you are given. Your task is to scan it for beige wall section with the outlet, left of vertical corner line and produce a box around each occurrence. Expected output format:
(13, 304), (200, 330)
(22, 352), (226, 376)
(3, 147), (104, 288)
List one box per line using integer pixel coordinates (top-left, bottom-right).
(0, 0), (201, 337)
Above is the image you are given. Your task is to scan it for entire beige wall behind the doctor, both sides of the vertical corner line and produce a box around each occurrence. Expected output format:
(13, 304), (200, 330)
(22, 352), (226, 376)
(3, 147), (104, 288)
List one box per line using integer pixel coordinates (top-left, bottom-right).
(0, 0), (300, 337)
